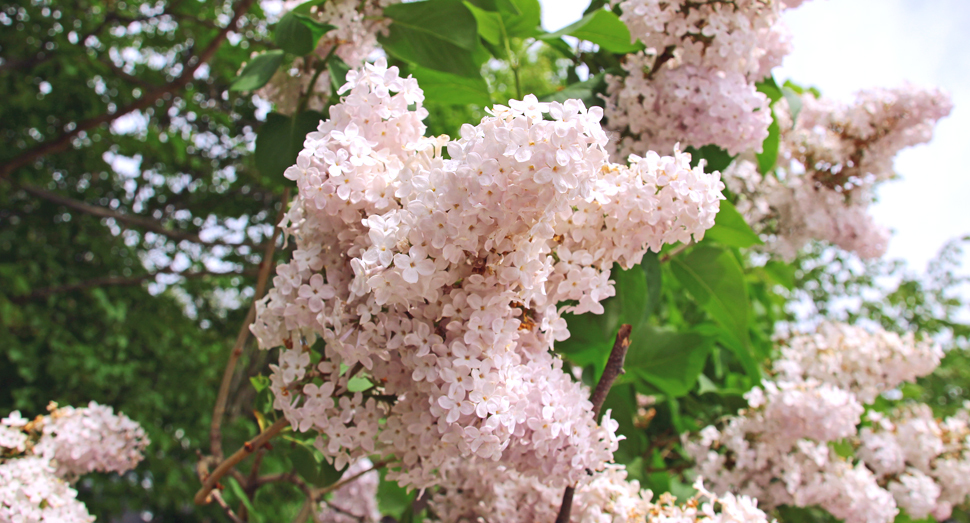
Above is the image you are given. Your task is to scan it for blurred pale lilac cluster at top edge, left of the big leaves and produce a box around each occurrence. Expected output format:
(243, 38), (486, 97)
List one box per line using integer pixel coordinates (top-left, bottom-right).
(257, 0), (401, 114)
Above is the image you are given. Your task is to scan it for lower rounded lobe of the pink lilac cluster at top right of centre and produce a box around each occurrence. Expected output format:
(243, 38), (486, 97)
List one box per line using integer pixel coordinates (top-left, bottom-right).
(606, 58), (771, 158)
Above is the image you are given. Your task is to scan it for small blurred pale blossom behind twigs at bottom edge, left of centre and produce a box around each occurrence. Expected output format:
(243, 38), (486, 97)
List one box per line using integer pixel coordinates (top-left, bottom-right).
(315, 458), (381, 523)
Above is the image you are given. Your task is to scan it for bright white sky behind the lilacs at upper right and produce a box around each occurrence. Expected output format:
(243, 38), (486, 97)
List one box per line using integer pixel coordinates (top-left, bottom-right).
(540, 0), (970, 271)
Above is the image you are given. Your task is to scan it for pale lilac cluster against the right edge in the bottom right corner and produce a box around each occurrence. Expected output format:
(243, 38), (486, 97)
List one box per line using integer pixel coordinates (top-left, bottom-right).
(856, 404), (970, 521)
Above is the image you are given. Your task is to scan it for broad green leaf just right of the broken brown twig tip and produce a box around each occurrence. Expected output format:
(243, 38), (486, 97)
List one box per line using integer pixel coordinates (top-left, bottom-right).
(624, 322), (713, 397)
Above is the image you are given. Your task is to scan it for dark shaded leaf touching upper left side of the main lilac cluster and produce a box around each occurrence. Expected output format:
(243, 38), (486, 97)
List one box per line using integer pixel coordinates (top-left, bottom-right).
(255, 111), (323, 187)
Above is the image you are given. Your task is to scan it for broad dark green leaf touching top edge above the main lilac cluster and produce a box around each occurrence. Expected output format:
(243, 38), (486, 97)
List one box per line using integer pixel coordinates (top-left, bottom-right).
(384, 0), (478, 51)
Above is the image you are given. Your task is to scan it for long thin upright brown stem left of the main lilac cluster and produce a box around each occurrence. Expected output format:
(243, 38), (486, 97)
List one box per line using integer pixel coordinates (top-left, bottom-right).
(209, 188), (290, 460)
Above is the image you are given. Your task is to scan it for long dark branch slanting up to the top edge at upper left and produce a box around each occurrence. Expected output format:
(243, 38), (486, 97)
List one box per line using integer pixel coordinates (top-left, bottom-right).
(0, 0), (255, 178)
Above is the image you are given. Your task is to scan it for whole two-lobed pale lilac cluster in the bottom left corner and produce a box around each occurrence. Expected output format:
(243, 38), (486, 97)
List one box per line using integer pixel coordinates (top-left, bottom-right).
(0, 401), (148, 523)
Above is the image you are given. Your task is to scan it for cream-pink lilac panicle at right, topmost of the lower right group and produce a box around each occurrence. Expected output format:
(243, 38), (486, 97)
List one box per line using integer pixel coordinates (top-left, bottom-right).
(774, 322), (943, 404)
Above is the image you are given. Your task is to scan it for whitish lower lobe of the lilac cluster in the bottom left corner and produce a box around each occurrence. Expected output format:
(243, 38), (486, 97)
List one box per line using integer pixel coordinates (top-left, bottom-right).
(0, 456), (94, 523)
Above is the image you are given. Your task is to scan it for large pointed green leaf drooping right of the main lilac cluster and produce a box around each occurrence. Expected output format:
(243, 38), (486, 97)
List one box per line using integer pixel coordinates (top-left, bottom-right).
(670, 245), (751, 351)
